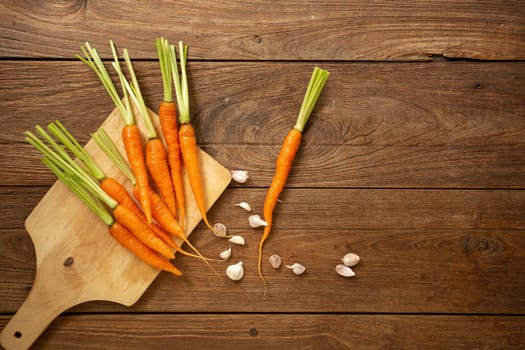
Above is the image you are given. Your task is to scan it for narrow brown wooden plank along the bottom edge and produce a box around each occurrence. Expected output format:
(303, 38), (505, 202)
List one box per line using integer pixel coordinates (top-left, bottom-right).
(0, 314), (524, 350)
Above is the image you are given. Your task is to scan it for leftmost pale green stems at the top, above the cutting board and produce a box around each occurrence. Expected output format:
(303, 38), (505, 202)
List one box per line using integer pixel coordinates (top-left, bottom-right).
(75, 42), (134, 125)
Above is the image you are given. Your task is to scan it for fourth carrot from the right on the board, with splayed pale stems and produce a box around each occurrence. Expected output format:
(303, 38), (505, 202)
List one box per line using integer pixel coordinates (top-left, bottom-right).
(76, 41), (152, 223)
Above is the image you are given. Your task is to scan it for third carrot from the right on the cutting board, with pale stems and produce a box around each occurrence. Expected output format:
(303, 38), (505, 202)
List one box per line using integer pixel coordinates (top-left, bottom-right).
(117, 49), (177, 214)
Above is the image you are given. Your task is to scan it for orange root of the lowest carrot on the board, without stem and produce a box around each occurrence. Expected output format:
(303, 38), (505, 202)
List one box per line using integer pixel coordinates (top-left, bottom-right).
(109, 221), (182, 276)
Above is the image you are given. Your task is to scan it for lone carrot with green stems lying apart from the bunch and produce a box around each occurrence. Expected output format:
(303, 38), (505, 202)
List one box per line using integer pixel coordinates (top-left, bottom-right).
(257, 67), (330, 294)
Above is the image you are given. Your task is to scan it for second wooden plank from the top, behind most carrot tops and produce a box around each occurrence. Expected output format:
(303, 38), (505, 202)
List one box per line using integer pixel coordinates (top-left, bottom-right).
(0, 61), (525, 188)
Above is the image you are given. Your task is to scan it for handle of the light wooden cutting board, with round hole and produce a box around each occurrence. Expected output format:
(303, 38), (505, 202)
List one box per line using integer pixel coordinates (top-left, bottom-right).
(0, 280), (76, 350)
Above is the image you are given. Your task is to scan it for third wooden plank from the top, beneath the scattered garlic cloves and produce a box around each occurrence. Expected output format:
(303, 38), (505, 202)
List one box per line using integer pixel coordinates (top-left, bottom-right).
(0, 189), (525, 314)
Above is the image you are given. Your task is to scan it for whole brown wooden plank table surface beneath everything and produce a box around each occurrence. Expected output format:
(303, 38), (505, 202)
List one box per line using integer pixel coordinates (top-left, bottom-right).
(0, 0), (525, 349)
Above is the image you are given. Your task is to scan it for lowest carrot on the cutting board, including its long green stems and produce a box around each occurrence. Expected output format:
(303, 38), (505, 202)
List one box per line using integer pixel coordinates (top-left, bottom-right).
(26, 134), (181, 276)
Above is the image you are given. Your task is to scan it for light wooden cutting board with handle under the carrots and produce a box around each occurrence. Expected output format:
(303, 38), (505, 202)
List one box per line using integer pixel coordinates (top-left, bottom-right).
(0, 110), (231, 350)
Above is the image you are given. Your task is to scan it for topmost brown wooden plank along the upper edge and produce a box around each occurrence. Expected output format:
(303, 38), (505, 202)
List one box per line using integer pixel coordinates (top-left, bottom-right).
(0, 0), (525, 61)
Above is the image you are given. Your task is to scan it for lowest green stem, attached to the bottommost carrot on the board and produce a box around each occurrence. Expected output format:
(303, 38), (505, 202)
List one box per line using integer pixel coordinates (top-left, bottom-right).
(42, 156), (114, 226)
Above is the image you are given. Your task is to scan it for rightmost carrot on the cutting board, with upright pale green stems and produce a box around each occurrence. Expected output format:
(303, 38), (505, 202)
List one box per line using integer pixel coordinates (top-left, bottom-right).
(170, 41), (221, 236)
